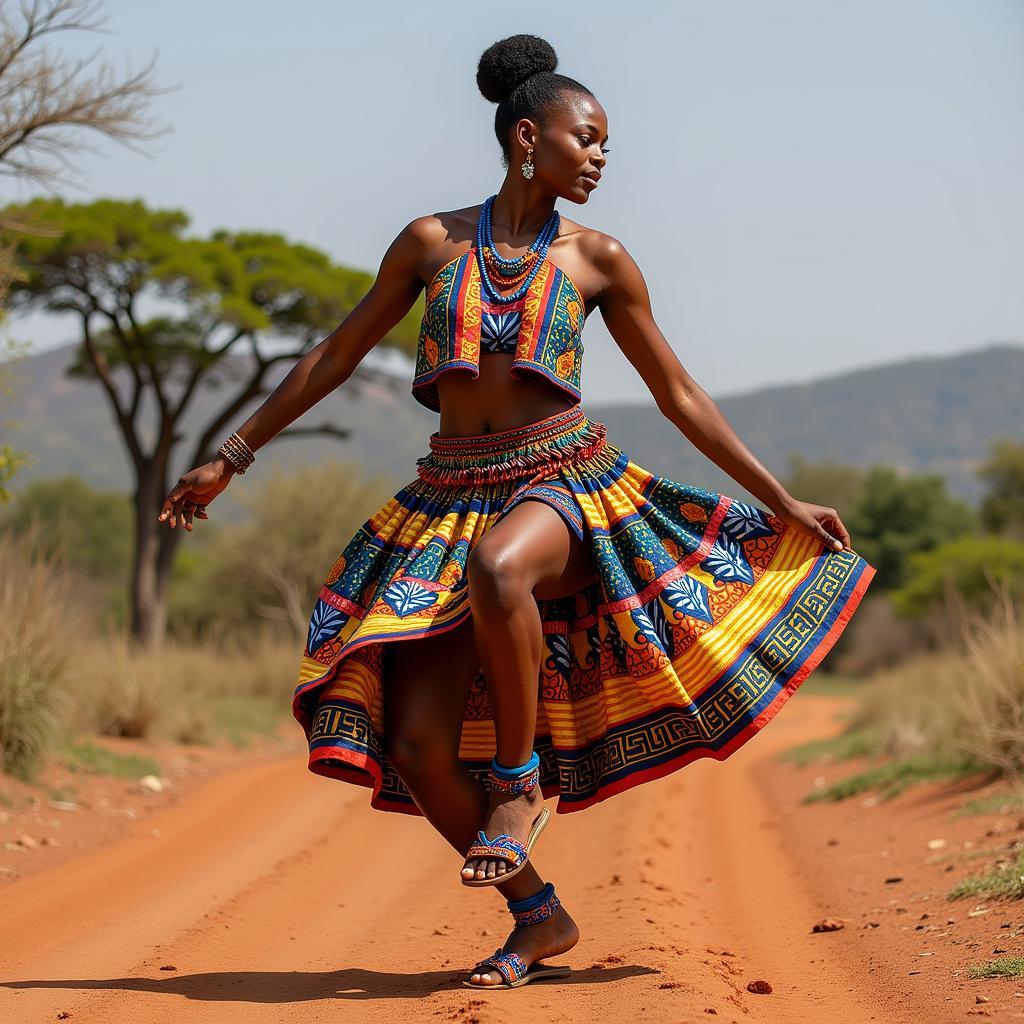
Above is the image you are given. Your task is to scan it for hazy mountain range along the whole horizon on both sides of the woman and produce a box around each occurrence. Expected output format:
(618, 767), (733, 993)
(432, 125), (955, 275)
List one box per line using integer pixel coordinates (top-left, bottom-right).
(5, 345), (1024, 512)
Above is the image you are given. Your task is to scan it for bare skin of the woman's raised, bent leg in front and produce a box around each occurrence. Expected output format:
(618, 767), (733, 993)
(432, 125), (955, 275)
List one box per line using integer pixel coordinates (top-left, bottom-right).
(462, 498), (596, 879)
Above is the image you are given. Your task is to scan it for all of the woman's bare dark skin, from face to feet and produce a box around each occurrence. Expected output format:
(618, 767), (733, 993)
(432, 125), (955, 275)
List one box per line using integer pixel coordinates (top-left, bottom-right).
(153, 92), (851, 984)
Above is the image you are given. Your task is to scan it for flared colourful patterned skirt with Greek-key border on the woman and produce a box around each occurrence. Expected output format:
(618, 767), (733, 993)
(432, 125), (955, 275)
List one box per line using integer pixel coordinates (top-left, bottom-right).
(292, 404), (874, 814)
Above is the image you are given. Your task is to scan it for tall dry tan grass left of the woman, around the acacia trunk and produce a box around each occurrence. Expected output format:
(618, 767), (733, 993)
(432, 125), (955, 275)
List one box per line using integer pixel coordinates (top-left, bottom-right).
(0, 522), (303, 781)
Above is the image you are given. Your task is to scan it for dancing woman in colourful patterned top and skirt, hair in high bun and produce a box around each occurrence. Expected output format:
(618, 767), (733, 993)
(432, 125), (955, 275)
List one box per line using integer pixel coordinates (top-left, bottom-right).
(160, 35), (873, 988)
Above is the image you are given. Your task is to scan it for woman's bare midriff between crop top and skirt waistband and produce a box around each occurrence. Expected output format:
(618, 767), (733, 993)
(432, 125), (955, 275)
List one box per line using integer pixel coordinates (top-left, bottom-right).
(436, 352), (577, 437)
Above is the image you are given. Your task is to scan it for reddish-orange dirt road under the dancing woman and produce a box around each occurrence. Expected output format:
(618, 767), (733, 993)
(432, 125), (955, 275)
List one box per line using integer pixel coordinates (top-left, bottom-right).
(0, 689), (995, 1024)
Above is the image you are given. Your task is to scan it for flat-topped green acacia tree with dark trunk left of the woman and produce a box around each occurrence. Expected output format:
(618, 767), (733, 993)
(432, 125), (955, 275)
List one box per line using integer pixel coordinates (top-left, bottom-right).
(0, 199), (416, 645)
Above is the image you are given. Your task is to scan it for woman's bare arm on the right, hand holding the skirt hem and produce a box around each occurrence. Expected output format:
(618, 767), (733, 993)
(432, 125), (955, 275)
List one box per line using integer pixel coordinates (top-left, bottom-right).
(591, 232), (851, 551)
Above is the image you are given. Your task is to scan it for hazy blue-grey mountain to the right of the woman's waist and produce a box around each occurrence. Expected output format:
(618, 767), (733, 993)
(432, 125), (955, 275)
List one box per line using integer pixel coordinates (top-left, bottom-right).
(598, 344), (1024, 501)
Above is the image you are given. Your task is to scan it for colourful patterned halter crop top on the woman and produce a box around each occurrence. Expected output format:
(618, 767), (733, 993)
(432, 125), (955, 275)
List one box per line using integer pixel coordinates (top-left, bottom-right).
(412, 246), (587, 413)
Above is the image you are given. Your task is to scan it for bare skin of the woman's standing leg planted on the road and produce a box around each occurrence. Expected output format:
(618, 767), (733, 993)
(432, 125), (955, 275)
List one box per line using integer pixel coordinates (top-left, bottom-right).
(383, 617), (580, 984)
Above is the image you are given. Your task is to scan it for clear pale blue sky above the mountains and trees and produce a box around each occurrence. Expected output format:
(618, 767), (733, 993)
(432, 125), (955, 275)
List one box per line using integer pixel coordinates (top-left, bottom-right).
(8, 0), (1024, 401)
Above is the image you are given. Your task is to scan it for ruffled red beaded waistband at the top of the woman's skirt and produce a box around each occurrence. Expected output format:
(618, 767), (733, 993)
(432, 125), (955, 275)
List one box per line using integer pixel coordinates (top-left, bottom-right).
(416, 404), (607, 486)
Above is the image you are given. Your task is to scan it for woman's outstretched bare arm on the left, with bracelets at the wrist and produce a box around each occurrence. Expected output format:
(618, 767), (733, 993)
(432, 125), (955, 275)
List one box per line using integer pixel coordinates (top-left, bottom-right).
(158, 217), (437, 530)
